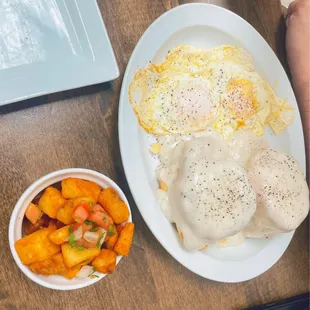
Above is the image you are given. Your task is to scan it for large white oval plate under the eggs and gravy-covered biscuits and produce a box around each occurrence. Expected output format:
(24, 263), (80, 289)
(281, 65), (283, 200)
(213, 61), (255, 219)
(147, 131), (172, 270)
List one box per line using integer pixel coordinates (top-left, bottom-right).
(119, 4), (305, 282)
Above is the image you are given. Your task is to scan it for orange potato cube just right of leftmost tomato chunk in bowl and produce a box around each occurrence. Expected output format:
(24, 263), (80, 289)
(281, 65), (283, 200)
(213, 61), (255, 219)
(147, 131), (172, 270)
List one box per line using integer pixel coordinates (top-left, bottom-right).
(39, 187), (66, 219)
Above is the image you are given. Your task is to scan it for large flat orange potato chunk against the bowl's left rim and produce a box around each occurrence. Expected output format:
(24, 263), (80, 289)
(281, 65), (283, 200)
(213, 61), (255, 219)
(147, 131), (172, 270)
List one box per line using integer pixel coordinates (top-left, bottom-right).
(15, 228), (60, 265)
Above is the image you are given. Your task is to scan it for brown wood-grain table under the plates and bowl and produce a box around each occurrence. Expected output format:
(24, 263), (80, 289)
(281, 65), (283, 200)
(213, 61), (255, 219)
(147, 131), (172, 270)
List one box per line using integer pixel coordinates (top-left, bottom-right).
(0, 0), (309, 310)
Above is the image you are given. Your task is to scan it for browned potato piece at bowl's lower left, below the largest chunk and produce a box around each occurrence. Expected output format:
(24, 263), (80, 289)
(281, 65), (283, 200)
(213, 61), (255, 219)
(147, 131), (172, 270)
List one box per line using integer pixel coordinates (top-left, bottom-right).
(29, 253), (67, 276)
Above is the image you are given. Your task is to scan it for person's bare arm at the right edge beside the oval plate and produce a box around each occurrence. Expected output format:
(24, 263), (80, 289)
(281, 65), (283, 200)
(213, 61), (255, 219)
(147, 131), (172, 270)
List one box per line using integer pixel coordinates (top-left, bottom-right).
(286, 0), (310, 160)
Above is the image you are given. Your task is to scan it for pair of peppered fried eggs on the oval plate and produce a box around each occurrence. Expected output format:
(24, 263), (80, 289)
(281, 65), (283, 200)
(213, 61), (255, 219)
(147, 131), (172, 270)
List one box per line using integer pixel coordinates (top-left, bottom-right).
(129, 46), (294, 138)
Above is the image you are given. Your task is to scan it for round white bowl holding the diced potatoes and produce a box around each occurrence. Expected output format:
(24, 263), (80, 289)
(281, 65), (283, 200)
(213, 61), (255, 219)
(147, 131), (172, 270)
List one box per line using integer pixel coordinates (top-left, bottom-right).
(9, 168), (132, 290)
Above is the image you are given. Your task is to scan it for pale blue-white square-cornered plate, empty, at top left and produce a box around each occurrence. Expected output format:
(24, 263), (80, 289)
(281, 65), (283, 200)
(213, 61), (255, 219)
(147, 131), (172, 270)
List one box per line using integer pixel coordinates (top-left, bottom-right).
(0, 0), (119, 105)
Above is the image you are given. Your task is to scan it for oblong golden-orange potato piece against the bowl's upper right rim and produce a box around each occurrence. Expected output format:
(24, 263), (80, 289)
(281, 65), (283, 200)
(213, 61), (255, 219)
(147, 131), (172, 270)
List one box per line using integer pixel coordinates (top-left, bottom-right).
(98, 187), (129, 224)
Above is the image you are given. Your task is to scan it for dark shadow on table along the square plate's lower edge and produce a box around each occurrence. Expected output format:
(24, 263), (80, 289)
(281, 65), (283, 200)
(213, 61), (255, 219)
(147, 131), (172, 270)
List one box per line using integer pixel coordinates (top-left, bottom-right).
(0, 82), (111, 115)
